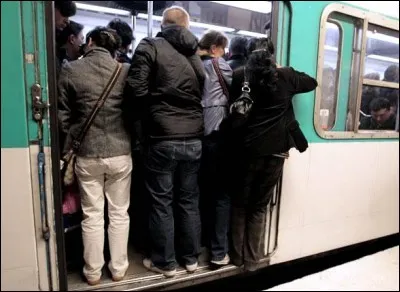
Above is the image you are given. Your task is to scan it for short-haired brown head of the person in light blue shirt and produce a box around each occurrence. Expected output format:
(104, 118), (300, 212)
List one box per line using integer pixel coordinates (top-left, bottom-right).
(199, 30), (228, 57)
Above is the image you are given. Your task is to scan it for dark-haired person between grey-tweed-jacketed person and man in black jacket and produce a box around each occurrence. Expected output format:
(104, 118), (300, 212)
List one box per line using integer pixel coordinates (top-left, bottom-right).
(107, 18), (135, 63)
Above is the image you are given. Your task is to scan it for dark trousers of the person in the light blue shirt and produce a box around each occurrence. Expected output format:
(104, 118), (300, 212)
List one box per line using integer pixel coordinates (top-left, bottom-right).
(200, 132), (231, 261)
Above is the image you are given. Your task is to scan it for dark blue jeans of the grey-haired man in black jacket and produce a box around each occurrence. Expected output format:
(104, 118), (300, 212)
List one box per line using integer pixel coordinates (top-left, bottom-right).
(145, 139), (202, 270)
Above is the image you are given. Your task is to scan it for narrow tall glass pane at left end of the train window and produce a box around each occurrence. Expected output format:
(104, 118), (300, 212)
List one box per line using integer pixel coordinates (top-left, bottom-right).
(320, 22), (341, 130)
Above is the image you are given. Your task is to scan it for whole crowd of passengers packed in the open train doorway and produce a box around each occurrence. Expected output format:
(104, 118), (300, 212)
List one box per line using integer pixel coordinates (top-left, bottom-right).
(55, 1), (317, 285)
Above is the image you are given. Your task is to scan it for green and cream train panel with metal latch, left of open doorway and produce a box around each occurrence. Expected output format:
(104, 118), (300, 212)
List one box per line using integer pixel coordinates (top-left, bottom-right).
(1, 1), (59, 290)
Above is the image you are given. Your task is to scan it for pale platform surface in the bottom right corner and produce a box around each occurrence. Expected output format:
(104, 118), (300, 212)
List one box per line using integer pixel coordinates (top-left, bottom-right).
(264, 246), (399, 291)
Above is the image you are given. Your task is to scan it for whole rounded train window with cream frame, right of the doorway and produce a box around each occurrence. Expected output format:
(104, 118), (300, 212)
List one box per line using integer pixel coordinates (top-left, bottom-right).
(314, 4), (399, 139)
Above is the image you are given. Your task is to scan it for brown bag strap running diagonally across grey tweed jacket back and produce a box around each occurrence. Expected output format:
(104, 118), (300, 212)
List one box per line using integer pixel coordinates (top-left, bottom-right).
(72, 63), (122, 151)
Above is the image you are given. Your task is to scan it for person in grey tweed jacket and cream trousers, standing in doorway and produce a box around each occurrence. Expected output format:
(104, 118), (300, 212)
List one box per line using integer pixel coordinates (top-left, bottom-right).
(58, 27), (132, 285)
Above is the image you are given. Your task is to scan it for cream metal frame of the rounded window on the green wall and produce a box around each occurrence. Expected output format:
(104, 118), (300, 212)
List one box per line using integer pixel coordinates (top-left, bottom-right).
(314, 3), (399, 139)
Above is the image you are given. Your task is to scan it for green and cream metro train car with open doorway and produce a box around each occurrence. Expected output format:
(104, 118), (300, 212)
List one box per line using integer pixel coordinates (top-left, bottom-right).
(1, 1), (399, 291)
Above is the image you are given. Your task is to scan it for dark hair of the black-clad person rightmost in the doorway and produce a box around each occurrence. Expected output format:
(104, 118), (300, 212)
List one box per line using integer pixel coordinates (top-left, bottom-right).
(246, 38), (278, 92)
